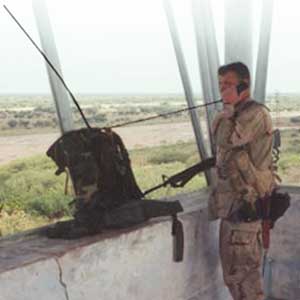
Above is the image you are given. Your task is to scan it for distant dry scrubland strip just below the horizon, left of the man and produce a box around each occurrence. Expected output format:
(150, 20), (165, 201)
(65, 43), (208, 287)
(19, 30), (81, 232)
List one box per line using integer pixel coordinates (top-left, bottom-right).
(0, 95), (204, 136)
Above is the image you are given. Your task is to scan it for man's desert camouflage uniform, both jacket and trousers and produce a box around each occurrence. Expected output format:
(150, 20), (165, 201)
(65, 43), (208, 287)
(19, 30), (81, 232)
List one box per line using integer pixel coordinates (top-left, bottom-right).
(209, 99), (274, 300)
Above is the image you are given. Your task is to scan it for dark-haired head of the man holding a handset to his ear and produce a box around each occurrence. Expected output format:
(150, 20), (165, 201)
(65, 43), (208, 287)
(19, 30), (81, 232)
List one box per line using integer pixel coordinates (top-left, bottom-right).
(218, 62), (250, 104)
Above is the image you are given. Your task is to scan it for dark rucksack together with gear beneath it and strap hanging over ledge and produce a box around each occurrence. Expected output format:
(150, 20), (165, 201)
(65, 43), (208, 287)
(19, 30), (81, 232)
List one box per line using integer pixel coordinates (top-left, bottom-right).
(46, 128), (183, 261)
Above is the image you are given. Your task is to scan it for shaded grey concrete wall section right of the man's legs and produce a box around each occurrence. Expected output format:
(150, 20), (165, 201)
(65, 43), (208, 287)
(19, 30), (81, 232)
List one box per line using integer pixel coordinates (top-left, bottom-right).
(265, 187), (300, 300)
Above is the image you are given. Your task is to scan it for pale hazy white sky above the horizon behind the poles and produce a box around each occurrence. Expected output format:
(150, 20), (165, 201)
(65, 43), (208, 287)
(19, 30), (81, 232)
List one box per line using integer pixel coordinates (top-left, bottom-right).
(0, 0), (300, 94)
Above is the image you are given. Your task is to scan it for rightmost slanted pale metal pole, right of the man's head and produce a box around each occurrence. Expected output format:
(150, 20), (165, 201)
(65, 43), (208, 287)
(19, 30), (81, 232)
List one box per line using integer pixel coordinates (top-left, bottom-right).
(254, 0), (274, 103)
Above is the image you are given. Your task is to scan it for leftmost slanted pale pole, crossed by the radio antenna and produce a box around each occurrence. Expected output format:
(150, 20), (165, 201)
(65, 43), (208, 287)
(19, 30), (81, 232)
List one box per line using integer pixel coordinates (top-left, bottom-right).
(32, 0), (73, 133)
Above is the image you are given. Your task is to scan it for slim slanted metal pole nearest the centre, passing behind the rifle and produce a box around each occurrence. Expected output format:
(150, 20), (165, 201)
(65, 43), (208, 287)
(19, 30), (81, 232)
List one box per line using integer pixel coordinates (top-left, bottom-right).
(163, 0), (211, 184)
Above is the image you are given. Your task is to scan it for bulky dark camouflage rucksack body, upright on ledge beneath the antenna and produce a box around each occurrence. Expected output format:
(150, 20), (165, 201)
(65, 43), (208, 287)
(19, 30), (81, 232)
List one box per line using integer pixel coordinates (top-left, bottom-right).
(47, 128), (142, 203)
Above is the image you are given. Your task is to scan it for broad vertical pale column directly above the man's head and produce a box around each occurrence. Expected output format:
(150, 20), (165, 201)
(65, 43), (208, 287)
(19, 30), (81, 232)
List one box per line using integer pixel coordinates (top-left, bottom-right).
(225, 0), (253, 77)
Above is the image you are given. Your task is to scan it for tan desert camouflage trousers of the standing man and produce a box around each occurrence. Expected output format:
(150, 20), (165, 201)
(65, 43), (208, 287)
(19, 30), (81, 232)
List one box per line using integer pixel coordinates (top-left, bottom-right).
(220, 220), (264, 300)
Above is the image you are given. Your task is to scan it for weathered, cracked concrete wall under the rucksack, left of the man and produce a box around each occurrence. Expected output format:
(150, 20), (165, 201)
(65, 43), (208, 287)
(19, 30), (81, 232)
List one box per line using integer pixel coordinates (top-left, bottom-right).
(0, 193), (229, 300)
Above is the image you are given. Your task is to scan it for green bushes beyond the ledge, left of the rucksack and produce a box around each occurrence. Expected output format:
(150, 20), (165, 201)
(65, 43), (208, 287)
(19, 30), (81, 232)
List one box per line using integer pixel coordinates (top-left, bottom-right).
(0, 156), (71, 217)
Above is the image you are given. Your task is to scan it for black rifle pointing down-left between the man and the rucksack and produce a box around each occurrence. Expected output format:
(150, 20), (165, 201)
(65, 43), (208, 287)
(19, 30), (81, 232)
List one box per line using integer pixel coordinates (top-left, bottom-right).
(143, 157), (216, 196)
